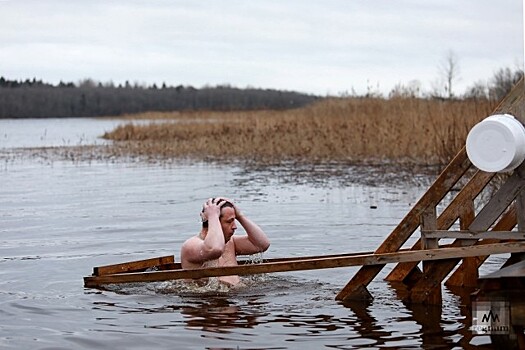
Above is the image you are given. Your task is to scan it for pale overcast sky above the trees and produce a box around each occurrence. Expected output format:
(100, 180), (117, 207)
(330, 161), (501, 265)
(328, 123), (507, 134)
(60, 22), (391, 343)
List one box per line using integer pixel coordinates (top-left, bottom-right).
(0, 0), (524, 95)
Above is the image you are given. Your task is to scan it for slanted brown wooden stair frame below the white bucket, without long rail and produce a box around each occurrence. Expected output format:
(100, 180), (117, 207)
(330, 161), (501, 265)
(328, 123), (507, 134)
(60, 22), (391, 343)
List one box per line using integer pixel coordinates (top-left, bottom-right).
(336, 78), (525, 304)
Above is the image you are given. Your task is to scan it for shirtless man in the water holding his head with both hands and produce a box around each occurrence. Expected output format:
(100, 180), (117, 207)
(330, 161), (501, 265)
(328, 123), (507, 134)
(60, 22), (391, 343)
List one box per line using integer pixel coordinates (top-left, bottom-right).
(180, 197), (270, 286)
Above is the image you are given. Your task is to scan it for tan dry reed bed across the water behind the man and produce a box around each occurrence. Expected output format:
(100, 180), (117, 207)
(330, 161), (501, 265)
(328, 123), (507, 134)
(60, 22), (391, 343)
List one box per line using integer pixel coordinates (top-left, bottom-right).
(104, 98), (494, 165)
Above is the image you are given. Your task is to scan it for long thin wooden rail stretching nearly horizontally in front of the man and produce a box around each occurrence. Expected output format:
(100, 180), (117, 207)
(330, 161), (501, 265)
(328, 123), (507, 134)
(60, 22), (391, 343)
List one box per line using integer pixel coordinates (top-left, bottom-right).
(84, 242), (525, 287)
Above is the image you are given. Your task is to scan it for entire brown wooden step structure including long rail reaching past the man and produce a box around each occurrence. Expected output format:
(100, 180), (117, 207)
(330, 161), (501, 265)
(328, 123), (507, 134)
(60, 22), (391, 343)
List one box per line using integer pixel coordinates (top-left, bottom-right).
(84, 79), (525, 304)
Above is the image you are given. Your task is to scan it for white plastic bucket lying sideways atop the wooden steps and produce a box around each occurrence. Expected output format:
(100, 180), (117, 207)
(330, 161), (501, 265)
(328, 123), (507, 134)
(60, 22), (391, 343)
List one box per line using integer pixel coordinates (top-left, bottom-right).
(467, 114), (525, 173)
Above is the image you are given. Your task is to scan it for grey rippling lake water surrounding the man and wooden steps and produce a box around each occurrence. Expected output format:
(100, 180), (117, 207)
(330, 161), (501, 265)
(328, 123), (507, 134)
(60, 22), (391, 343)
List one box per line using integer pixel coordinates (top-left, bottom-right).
(0, 119), (503, 349)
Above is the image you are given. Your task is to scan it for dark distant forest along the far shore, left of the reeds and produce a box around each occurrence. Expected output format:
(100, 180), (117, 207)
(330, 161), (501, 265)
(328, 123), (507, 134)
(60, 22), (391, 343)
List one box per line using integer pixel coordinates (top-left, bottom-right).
(0, 77), (319, 118)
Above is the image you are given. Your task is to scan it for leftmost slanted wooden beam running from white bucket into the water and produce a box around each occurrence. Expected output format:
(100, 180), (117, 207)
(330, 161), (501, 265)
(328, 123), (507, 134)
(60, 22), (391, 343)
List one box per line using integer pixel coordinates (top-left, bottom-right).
(336, 147), (471, 300)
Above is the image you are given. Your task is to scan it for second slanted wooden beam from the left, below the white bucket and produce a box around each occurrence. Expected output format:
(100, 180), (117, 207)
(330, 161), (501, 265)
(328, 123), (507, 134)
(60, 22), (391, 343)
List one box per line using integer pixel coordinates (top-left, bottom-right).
(385, 171), (495, 282)
